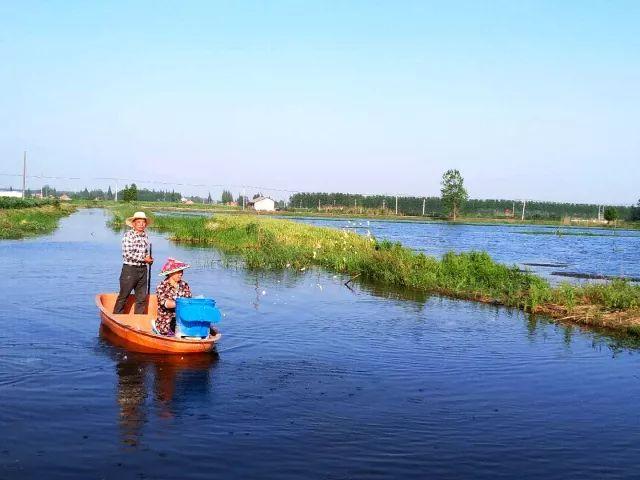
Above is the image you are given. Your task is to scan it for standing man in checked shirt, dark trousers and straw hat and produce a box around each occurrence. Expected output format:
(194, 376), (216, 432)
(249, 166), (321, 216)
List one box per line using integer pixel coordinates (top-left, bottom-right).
(113, 212), (153, 314)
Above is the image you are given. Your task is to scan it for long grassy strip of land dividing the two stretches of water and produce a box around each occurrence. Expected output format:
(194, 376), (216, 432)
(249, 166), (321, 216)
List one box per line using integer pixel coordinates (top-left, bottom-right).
(112, 206), (640, 336)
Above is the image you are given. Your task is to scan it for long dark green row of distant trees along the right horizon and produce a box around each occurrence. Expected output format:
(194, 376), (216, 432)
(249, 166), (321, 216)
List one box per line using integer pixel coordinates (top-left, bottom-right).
(288, 192), (640, 220)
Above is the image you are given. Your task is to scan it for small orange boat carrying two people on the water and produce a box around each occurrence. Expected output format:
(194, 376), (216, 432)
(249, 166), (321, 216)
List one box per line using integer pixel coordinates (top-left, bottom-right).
(96, 293), (222, 354)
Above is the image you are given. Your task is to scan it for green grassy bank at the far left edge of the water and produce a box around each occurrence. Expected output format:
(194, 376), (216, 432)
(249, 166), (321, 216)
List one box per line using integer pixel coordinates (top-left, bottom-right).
(0, 198), (75, 239)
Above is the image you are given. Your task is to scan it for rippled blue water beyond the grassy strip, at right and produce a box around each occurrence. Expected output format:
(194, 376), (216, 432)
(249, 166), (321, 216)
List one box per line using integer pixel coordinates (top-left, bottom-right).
(297, 218), (640, 281)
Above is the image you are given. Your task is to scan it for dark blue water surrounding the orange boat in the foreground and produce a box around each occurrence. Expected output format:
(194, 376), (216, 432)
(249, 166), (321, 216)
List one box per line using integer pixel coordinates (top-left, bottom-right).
(0, 210), (640, 480)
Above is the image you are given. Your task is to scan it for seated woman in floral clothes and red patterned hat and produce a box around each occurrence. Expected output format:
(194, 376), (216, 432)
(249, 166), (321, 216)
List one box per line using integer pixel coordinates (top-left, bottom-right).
(155, 258), (191, 336)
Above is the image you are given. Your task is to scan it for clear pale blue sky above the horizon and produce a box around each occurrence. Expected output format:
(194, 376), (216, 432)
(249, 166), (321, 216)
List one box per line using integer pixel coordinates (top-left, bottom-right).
(0, 0), (640, 204)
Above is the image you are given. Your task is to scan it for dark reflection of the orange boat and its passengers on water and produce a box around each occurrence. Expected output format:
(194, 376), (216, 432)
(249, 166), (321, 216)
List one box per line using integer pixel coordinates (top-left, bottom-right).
(100, 326), (218, 446)
